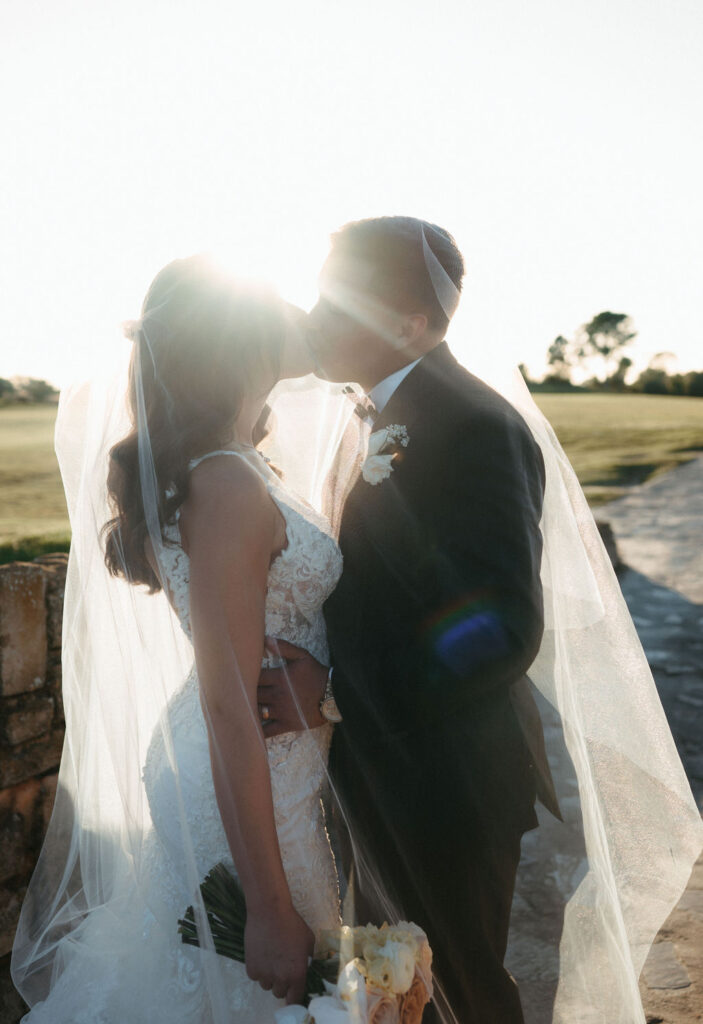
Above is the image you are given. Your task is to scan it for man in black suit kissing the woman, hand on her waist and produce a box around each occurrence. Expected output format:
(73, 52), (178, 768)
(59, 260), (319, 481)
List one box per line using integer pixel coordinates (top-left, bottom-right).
(260, 217), (558, 1024)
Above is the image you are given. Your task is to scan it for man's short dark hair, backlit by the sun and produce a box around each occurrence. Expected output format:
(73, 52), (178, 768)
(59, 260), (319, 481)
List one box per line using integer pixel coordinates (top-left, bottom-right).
(331, 217), (465, 331)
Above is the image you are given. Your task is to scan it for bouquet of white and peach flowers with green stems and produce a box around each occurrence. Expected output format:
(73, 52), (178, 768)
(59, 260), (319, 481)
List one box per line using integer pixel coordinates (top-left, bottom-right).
(178, 864), (432, 1024)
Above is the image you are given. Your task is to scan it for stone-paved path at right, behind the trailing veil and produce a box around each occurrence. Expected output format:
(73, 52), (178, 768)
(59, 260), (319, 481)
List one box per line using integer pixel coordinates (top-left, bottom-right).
(508, 458), (703, 1024)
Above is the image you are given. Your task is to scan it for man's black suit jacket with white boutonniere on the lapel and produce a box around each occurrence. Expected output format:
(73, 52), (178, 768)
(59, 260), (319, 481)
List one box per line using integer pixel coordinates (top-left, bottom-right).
(324, 343), (544, 937)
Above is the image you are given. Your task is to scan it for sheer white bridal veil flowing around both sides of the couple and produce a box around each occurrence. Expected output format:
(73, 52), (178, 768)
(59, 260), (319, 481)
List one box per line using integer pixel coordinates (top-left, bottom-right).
(12, 241), (703, 1024)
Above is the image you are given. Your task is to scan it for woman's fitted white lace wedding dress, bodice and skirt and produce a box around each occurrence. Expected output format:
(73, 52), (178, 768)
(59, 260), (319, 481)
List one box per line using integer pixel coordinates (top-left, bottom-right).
(24, 450), (342, 1024)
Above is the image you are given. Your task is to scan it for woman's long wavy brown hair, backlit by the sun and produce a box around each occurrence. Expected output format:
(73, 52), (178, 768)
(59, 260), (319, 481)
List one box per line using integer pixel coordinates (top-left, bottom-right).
(103, 256), (284, 593)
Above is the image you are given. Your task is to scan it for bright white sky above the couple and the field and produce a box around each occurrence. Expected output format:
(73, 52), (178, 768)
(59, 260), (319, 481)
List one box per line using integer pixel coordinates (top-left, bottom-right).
(0, 0), (703, 384)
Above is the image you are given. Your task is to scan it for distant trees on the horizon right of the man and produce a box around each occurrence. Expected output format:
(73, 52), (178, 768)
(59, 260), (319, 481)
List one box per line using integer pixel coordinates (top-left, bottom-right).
(520, 310), (703, 397)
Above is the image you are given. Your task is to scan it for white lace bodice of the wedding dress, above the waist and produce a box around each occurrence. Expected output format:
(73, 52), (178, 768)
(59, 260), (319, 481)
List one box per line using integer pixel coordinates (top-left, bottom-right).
(161, 445), (342, 665)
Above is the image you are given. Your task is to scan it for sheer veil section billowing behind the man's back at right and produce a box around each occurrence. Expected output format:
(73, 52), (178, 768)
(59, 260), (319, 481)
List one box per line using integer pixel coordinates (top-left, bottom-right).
(422, 228), (703, 1024)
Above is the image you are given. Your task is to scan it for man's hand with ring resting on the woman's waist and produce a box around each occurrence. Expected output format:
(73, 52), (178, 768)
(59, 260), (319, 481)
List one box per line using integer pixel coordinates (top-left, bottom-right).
(257, 637), (327, 737)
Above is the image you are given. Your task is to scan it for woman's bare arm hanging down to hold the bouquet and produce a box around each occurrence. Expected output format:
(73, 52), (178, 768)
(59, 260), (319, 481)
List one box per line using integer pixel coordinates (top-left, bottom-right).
(181, 458), (313, 1002)
